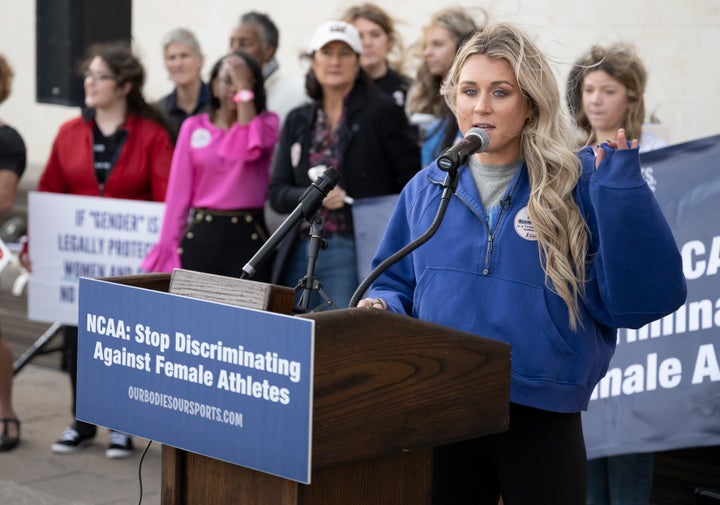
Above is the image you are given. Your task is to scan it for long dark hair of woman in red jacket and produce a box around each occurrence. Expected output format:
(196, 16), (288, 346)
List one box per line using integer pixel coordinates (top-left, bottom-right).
(80, 41), (169, 133)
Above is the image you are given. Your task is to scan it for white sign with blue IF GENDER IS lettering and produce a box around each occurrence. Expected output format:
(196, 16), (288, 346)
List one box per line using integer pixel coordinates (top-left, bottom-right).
(28, 191), (165, 325)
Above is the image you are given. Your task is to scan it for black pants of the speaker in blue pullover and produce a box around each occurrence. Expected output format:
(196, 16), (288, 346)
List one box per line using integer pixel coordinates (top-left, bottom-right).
(433, 404), (587, 505)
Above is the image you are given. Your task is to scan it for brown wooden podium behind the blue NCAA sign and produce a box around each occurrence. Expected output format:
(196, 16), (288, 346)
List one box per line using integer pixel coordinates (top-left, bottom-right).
(105, 270), (510, 505)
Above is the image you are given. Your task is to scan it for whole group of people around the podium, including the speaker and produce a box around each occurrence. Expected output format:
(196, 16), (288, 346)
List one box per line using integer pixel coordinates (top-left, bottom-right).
(0, 3), (685, 505)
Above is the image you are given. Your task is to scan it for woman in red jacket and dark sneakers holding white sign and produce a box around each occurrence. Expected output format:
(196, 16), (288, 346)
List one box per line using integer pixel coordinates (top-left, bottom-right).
(27, 43), (173, 458)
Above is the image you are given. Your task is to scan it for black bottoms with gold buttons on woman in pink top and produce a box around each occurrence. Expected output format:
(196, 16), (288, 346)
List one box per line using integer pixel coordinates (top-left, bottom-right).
(180, 209), (272, 282)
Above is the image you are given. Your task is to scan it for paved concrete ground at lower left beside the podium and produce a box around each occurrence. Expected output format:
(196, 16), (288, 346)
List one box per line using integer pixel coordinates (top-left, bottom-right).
(0, 363), (161, 505)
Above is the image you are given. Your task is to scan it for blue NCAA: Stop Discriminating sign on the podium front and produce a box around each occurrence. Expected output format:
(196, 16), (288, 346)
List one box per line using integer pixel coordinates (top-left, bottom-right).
(77, 278), (315, 484)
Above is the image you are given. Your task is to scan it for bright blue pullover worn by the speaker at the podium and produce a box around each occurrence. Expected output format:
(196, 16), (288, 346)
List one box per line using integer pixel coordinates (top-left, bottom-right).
(369, 144), (686, 412)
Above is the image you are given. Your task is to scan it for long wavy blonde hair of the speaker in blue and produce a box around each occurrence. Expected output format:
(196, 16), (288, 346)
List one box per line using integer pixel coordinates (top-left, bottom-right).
(441, 23), (588, 330)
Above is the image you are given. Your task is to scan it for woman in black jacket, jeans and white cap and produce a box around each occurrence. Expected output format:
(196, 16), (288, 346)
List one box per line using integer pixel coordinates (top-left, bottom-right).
(269, 21), (420, 308)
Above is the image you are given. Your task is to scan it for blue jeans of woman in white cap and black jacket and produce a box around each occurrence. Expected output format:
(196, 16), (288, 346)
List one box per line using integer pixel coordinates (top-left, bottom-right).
(281, 234), (359, 311)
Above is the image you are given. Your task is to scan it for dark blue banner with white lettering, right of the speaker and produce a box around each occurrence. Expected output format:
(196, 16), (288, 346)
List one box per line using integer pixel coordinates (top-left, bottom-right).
(583, 135), (720, 459)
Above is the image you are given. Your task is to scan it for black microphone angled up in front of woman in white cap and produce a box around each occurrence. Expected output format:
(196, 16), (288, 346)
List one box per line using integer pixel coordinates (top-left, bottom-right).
(241, 167), (340, 279)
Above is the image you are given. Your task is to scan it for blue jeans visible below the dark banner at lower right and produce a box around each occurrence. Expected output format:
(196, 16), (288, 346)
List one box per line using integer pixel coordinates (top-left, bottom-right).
(587, 452), (654, 505)
